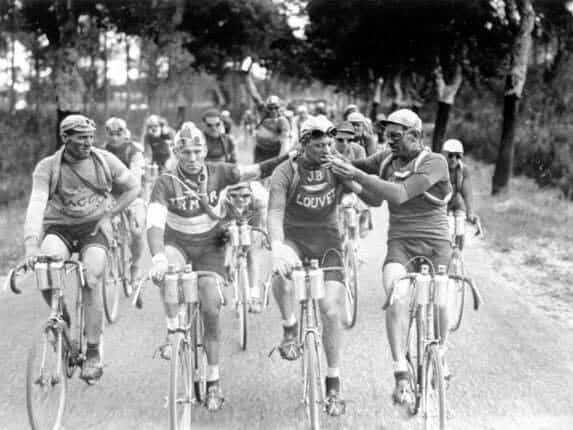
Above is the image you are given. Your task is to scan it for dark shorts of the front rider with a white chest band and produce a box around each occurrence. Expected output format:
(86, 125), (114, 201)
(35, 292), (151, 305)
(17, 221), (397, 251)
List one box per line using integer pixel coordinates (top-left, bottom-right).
(165, 228), (225, 276)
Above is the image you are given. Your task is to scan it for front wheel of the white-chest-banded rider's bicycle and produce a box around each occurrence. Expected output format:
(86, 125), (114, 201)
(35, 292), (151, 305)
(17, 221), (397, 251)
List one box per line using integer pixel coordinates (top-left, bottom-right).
(167, 333), (193, 430)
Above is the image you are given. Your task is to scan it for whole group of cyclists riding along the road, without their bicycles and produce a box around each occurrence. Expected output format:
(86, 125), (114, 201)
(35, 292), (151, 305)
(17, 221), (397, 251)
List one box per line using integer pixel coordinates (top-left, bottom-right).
(24, 88), (475, 416)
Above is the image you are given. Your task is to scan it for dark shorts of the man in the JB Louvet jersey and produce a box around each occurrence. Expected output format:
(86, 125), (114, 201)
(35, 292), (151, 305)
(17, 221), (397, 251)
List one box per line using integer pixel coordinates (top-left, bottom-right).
(285, 227), (344, 282)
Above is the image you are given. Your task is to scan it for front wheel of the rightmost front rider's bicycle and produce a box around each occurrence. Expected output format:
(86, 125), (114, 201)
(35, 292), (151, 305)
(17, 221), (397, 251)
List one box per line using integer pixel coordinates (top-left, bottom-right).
(424, 345), (446, 430)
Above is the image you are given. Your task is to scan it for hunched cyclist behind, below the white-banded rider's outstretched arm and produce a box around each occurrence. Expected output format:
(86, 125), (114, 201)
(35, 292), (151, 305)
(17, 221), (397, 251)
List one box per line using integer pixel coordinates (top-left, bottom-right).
(223, 181), (269, 313)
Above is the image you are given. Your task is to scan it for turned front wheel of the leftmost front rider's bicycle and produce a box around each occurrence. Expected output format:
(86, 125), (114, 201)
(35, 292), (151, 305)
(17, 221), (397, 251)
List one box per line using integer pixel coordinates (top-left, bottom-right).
(26, 324), (67, 430)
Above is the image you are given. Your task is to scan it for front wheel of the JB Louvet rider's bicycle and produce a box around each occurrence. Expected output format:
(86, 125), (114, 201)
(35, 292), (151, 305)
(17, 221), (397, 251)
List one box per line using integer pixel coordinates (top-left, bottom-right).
(303, 332), (321, 430)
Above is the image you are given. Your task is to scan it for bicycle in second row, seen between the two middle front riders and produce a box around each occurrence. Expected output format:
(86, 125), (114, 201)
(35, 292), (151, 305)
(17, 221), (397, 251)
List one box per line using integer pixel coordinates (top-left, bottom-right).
(225, 220), (270, 351)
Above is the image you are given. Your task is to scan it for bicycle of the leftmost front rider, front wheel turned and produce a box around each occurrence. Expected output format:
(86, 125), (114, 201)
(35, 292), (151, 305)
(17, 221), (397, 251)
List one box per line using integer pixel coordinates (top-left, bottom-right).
(5, 256), (101, 430)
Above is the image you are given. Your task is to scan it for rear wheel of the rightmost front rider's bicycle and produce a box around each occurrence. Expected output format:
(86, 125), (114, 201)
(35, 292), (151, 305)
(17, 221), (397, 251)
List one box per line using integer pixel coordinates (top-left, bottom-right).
(406, 307), (423, 415)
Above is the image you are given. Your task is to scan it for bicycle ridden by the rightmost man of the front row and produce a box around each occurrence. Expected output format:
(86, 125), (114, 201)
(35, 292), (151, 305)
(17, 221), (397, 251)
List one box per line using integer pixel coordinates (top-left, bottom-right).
(383, 257), (482, 430)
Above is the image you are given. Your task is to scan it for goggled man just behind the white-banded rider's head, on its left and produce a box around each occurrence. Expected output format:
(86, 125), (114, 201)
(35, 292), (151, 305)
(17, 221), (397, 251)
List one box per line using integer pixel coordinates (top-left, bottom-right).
(141, 115), (173, 172)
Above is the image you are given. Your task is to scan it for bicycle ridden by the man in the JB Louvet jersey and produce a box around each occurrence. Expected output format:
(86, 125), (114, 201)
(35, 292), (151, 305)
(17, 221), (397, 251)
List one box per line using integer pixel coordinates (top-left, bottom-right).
(291, 259), (344, 430)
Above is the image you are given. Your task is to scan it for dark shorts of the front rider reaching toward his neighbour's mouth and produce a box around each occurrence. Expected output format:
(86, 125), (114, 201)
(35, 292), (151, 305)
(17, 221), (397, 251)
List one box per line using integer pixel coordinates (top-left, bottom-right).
(384, 239), (452, 270)
